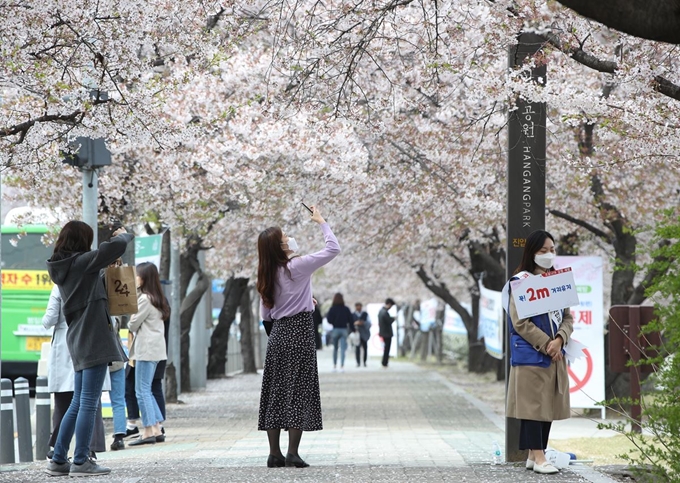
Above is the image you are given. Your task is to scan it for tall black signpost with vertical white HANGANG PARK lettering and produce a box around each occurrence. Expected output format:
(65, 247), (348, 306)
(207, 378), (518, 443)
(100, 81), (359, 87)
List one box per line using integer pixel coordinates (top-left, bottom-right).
(504, 33), (547, 461)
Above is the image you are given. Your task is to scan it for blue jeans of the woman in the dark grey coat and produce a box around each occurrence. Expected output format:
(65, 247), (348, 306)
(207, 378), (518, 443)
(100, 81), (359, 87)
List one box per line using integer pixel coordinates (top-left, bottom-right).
(52, 364), (109, 465)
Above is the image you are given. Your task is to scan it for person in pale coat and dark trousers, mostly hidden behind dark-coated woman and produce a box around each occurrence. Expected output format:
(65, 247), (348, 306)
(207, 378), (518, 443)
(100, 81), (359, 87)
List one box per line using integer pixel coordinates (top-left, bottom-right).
(42, 285), (108, 459)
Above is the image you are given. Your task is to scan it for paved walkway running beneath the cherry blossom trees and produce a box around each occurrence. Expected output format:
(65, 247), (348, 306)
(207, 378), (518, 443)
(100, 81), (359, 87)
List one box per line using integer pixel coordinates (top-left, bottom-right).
(0, 348), (613, 483)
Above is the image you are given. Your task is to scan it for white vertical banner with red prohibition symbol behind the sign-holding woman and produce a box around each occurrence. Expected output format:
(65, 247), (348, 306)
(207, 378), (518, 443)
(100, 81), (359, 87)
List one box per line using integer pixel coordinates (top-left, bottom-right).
(555, 256), (605, 408)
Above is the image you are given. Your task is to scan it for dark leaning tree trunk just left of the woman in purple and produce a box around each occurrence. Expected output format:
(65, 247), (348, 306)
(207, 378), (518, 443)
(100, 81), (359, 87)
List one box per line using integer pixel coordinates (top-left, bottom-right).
(208, 277), (248, 379)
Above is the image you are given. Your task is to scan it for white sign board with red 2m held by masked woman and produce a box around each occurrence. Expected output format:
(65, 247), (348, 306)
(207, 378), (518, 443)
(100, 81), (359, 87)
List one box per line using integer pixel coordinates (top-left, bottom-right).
(510, 268), (579, 319)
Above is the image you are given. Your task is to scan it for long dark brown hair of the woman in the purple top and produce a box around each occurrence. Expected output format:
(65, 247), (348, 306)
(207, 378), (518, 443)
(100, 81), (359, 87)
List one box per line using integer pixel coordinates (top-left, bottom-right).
(257, 226), (290, 309)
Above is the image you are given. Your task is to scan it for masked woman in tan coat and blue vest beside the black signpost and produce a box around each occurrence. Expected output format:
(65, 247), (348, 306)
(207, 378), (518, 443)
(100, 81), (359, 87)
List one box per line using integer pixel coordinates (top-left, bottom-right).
(503, 230), (574, 474)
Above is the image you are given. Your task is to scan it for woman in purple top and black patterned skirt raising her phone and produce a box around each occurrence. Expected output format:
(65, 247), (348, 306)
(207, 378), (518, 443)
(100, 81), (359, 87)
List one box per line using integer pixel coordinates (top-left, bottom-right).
(257, 206), (340, 468)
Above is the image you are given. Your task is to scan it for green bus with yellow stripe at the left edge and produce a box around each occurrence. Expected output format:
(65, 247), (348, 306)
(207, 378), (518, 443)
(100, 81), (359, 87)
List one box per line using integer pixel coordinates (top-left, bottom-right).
(0, 225), (54, 380)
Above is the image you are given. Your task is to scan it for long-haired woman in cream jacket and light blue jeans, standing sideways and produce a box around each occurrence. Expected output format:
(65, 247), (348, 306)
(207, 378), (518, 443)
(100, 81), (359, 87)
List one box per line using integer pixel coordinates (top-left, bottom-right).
(128, 262), (170, 446)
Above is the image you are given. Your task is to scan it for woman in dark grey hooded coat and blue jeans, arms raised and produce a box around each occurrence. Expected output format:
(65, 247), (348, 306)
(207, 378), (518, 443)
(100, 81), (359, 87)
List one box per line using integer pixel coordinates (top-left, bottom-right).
(45, 221), (134, 476)
